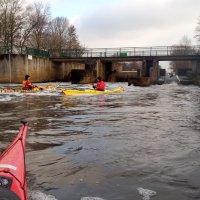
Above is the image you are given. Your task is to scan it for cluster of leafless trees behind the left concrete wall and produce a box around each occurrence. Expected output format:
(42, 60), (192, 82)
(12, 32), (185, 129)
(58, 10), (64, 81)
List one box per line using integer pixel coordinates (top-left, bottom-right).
(0, 0), (84, 56)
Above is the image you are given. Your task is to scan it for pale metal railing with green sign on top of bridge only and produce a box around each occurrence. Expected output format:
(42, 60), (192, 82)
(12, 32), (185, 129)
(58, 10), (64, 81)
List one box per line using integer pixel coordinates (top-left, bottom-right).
(49, 46), (200, 58)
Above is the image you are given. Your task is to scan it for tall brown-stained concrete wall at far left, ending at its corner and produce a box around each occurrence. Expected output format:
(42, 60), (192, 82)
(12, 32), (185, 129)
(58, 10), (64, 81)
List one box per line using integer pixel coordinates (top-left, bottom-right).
(0, 55), (54, 83)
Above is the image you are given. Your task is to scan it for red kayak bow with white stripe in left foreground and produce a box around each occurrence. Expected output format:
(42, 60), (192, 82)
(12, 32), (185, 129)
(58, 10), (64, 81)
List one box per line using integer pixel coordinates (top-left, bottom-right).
(0, 122), (28, 200)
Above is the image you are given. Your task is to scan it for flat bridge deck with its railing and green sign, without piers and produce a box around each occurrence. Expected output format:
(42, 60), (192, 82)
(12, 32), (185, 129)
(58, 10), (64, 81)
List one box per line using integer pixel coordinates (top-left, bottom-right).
(49, 46), (200, 61)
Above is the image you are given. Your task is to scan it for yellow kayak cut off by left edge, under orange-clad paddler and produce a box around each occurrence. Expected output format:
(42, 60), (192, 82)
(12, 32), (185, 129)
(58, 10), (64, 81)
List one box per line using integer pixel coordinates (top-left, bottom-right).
(0, 84), (59, 93)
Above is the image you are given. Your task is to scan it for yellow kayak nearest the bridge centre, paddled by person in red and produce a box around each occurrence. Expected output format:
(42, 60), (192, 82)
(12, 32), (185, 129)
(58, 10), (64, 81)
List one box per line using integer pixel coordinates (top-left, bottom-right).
(62, 87), (124, 96)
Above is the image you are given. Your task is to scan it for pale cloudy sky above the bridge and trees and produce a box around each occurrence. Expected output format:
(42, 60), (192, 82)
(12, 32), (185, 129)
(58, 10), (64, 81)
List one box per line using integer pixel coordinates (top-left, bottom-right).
(32, 0), (200, 48)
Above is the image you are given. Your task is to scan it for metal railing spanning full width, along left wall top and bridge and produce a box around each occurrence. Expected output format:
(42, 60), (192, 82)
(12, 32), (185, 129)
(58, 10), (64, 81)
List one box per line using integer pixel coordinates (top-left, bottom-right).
(0, 45), (200, 59)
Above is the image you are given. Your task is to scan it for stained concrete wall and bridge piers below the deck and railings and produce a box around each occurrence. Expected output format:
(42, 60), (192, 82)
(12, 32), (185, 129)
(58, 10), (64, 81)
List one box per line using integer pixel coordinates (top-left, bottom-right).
(0, 54), (159, 83)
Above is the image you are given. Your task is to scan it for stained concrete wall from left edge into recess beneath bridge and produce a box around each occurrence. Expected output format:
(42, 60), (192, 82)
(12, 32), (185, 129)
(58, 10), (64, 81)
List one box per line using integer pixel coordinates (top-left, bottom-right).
(0, 54), (85, 83)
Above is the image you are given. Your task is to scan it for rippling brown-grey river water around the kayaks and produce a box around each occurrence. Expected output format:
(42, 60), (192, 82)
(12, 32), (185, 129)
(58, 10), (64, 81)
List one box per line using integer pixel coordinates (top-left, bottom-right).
(0, 83), (200, 200)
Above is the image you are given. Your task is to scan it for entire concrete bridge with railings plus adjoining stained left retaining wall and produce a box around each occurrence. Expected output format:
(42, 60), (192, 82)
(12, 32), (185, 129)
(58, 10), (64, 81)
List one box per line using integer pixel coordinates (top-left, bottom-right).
(0, 46), (200, 85)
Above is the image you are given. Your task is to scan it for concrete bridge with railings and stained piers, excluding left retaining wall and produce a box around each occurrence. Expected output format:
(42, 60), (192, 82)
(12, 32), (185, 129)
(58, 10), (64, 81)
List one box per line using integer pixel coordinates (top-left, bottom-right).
(49, 46), (200, 85)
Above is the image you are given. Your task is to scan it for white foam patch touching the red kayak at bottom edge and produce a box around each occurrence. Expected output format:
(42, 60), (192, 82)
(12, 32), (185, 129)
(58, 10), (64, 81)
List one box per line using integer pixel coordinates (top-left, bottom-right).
(28, 190), (58, 200)
